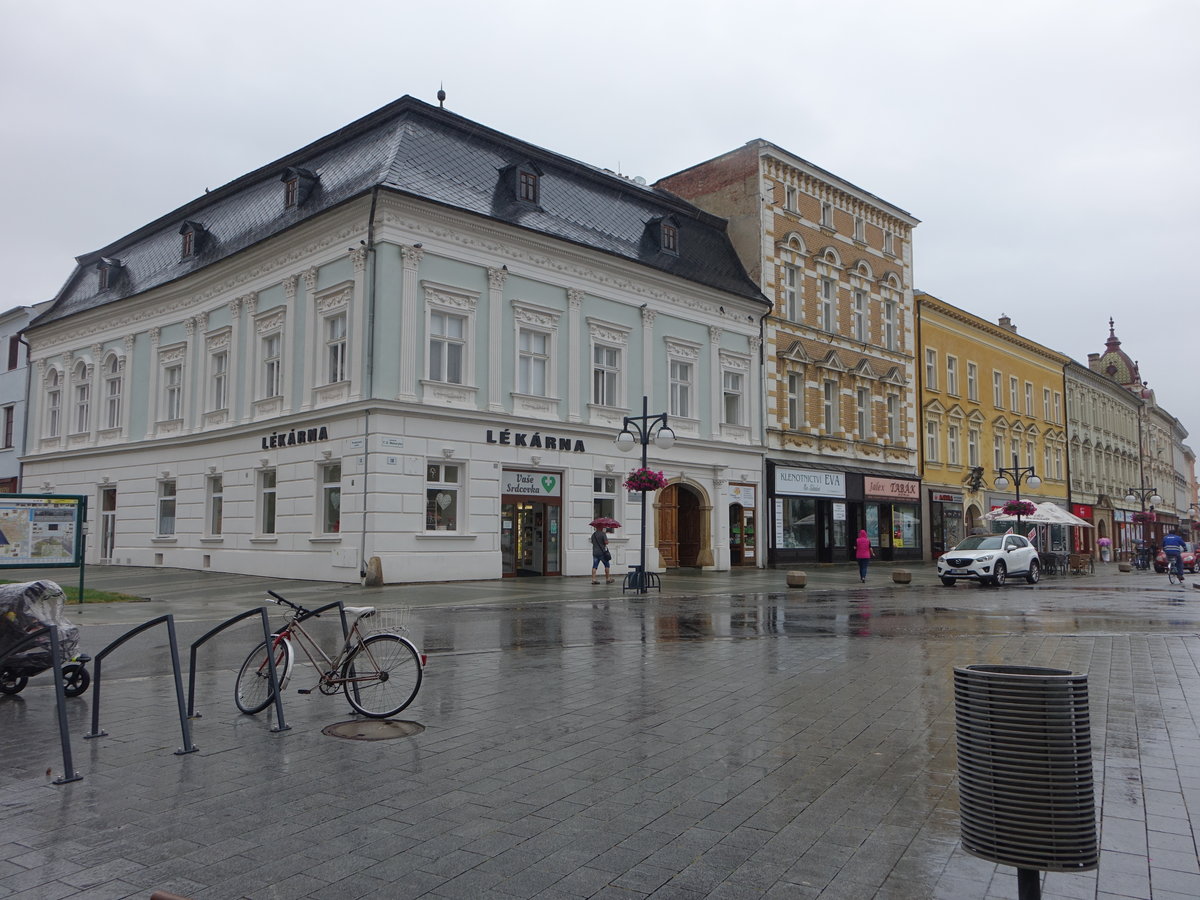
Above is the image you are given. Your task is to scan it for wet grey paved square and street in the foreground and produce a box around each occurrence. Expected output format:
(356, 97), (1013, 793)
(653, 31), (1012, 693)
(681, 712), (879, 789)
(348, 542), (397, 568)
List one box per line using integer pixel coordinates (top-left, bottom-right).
(0, 566), (1200, 900)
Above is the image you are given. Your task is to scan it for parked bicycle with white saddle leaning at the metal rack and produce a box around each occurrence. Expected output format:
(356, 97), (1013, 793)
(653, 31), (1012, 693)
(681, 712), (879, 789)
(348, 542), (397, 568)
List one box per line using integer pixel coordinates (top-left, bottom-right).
(234, 590), (426, 719)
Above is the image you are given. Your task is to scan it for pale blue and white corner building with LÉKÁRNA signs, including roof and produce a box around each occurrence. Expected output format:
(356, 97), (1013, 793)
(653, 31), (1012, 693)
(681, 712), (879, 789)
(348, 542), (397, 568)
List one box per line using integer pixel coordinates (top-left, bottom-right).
(25, 97), (768, 582)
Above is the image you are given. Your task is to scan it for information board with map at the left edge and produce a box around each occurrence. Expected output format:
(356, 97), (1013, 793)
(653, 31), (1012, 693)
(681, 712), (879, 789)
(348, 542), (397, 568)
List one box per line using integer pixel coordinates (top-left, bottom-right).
(0, 493), (88, 569)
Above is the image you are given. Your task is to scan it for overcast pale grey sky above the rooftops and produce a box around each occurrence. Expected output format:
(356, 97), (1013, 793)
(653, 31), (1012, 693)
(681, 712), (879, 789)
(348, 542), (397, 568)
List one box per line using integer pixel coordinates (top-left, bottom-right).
(0, 0), (1200, 450)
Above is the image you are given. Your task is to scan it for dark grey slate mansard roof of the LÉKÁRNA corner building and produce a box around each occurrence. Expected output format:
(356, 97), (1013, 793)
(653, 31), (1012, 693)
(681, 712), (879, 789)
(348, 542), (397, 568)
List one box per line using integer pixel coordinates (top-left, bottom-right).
(34, 96), (769, 325)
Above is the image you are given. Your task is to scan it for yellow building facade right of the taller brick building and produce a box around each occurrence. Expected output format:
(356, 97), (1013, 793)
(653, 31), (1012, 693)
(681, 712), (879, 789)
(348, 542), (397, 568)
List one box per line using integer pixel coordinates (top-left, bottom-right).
(914, 292), (1070, 558)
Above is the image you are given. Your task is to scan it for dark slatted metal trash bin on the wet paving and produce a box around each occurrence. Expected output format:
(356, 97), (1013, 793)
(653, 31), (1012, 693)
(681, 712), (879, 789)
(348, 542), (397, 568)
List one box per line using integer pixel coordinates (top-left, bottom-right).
(954, 665), (1099, 900)
